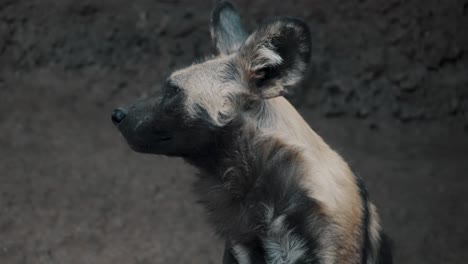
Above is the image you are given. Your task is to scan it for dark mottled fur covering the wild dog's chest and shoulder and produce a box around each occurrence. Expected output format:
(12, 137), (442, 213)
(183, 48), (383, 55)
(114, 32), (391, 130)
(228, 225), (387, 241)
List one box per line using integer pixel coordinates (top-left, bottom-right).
(188, 121), (327, 263)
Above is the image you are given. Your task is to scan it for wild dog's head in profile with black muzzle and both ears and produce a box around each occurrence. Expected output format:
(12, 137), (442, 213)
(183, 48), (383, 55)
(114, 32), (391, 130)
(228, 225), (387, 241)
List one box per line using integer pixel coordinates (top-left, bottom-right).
(112, 2), (311, 156)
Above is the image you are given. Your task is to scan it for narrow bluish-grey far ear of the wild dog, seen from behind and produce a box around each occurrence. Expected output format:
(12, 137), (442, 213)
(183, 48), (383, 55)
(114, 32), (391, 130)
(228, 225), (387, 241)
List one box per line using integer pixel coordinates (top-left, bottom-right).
(210, 1), (248, 55)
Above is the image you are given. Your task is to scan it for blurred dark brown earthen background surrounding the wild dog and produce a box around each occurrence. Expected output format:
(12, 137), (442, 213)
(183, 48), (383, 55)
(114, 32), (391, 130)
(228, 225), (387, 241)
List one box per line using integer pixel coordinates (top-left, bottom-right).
(0, 0), (468, 264)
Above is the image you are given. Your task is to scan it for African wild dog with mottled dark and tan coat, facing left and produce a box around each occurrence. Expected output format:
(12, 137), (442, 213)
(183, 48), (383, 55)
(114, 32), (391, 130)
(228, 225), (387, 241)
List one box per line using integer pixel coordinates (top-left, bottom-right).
(112, 2), (391, 264)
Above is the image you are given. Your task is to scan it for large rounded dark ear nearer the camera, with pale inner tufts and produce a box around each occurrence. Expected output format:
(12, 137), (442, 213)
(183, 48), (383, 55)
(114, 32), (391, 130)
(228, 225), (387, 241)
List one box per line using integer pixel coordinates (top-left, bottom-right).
(238, 18), (311, 99)
